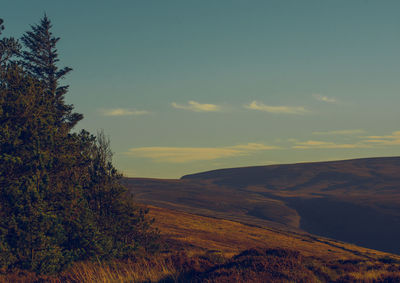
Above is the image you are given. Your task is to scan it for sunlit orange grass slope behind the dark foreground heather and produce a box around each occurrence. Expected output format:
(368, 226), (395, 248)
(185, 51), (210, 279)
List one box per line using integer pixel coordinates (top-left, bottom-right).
(150, 204), (400, 260)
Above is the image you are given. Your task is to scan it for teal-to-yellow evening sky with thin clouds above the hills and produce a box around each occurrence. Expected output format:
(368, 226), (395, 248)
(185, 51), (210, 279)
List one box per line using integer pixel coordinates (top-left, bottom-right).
(0, 0), (400, 178)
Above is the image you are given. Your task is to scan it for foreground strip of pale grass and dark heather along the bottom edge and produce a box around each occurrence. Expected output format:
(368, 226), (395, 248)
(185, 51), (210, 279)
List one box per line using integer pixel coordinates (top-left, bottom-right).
(0, 248), (400, 283)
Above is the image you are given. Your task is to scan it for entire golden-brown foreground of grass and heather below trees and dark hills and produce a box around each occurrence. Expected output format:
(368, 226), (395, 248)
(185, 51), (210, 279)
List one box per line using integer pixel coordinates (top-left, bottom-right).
(0, 207), (400, 283)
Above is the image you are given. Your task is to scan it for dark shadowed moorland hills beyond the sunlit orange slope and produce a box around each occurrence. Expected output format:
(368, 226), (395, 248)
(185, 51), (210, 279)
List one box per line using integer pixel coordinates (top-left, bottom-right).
(123, 157), (400, 254)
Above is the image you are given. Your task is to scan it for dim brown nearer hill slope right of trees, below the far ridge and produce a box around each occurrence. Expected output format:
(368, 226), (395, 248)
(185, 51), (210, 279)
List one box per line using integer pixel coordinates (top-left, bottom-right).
(122, 178), (300, 231)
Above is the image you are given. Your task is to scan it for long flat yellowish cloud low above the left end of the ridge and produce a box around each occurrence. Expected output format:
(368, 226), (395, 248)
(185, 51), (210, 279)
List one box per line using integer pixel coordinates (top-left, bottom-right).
(126, 143), (279, 163)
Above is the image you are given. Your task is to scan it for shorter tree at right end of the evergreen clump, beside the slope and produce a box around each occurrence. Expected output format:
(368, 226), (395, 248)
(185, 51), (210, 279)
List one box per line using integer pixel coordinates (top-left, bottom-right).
(85, 131), (157, 257)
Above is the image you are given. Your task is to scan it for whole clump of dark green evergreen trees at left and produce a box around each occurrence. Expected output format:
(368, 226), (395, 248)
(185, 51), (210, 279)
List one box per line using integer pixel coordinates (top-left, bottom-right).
(0, 16), (156, 273)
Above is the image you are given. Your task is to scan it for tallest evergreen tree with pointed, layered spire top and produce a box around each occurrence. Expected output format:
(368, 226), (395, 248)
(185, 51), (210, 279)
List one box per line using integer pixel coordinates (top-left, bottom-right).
(20, 15), (99, 260)
